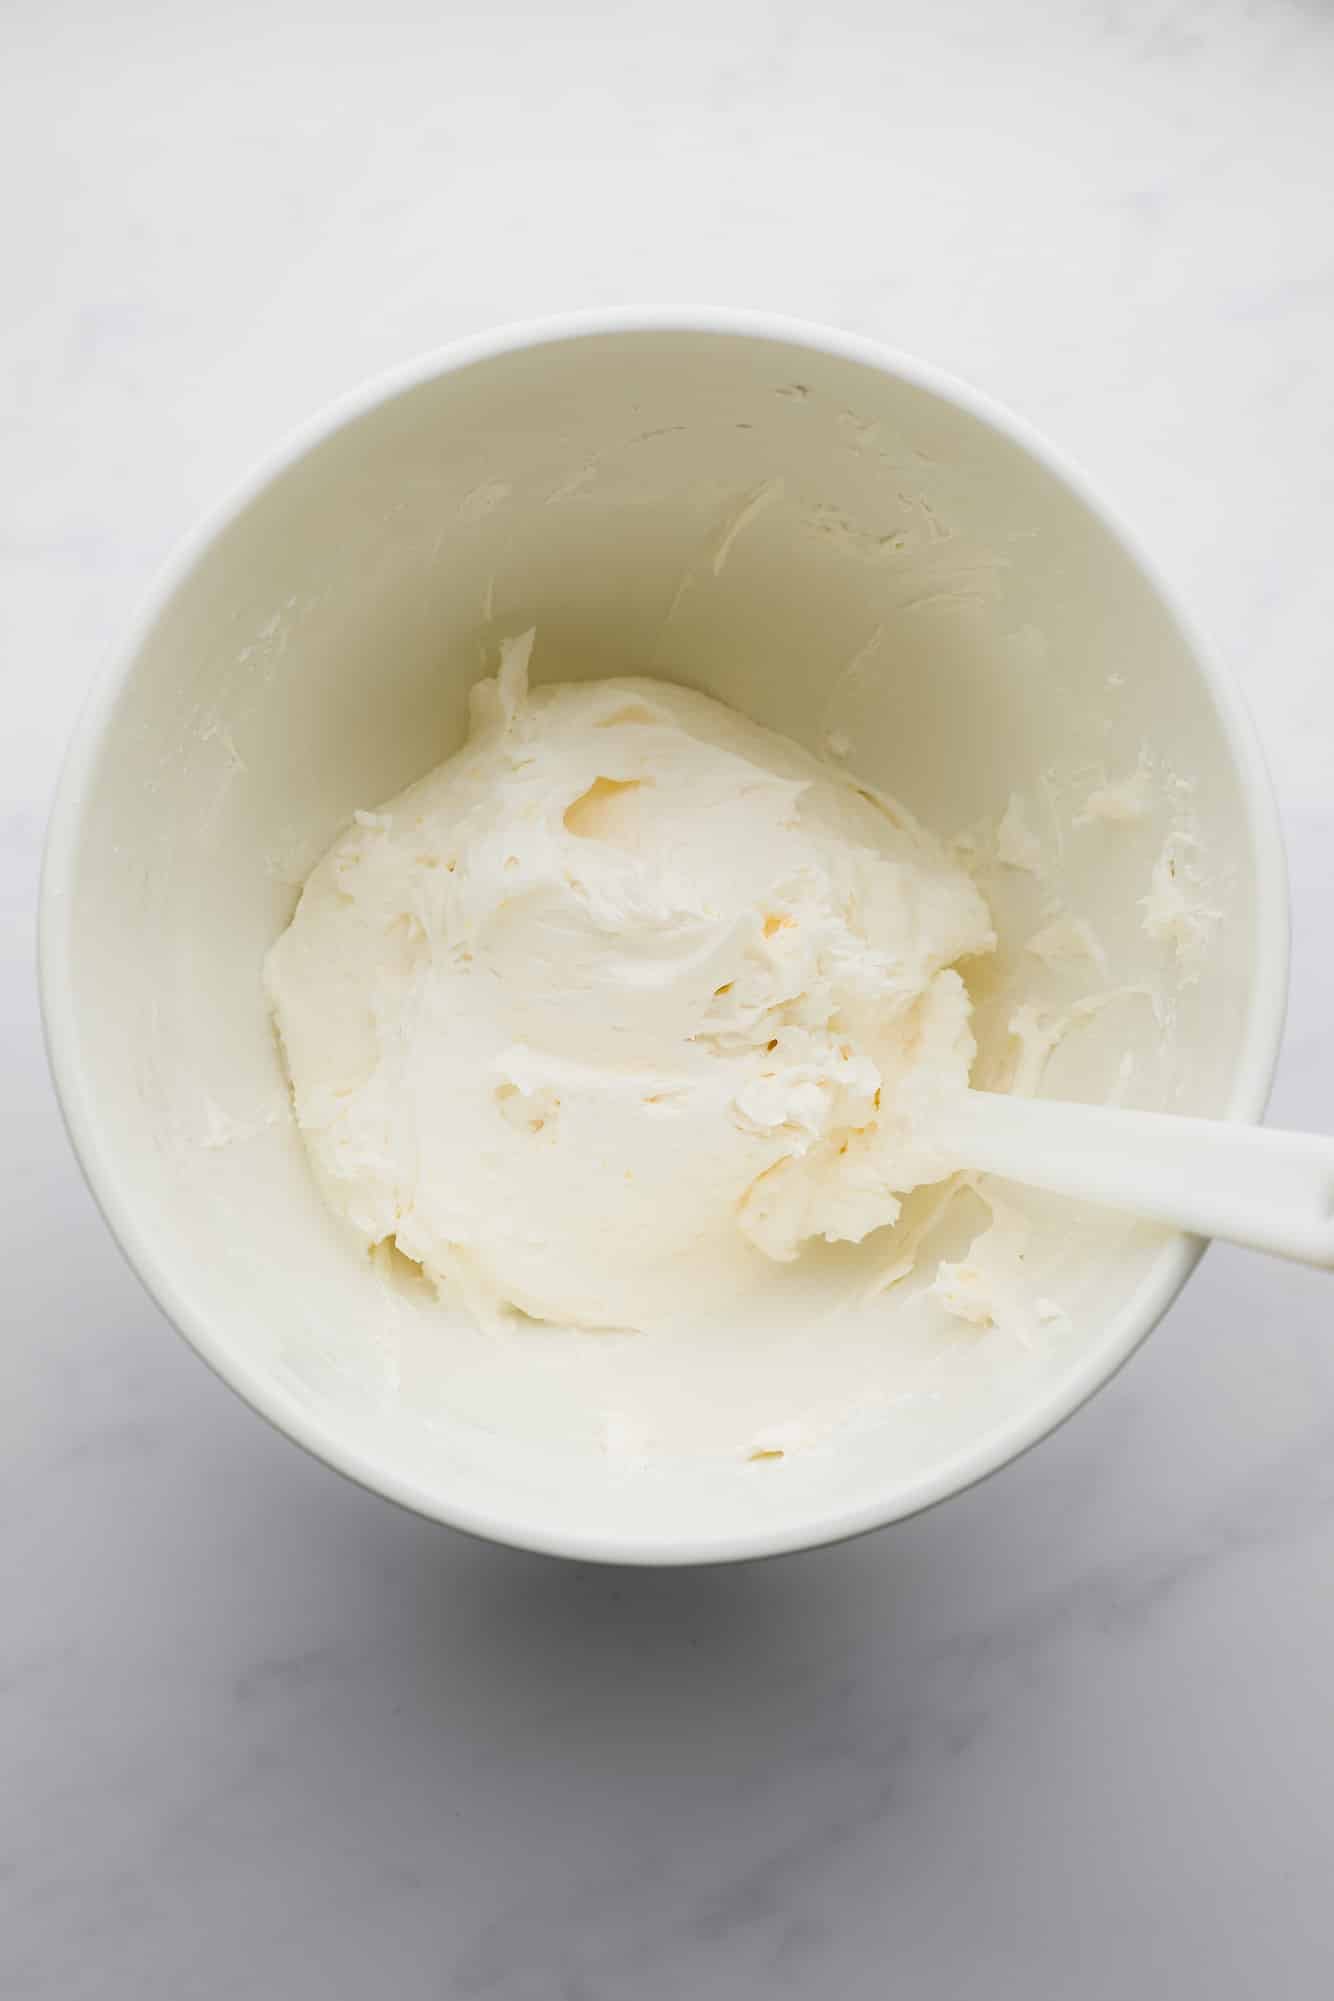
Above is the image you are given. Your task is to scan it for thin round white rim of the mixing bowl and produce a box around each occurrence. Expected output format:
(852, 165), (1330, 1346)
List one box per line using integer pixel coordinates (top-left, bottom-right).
(38, 304), (1290, 1567)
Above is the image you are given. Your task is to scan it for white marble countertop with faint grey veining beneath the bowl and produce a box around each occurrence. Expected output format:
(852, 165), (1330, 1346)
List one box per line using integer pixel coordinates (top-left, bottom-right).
(0, 0), (1334, 2001)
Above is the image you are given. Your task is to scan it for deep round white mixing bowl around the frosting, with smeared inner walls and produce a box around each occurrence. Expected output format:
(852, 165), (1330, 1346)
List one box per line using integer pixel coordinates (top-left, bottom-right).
(42, 310), (1288, 1563)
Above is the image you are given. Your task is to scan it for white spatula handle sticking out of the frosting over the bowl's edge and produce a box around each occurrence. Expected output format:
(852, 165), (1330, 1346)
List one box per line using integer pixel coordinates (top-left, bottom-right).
(938, 1091), (1334, 1267)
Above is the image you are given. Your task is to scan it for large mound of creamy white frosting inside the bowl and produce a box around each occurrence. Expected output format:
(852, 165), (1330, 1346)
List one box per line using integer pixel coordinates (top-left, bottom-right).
(266, 634), (994, 1327)
